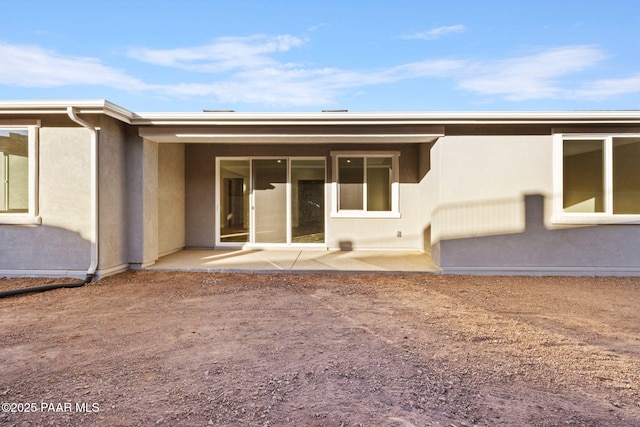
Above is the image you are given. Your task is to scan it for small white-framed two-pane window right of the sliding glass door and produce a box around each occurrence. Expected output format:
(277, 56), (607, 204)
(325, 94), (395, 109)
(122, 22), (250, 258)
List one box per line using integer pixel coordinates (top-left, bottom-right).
(332, 152), (399, 217)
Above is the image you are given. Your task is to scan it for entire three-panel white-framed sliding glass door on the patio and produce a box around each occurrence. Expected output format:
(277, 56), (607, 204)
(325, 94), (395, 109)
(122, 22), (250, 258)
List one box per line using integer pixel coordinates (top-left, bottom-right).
(216, 157), (326, 246)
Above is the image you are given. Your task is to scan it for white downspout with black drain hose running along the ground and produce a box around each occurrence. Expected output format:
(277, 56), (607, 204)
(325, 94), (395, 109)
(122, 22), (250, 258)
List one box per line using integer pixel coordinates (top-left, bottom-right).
(0, 107), (99, 298)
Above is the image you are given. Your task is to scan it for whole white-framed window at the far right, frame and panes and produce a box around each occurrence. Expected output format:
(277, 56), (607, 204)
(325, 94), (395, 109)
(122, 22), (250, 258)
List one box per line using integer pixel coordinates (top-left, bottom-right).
(554, 136), (640, 223)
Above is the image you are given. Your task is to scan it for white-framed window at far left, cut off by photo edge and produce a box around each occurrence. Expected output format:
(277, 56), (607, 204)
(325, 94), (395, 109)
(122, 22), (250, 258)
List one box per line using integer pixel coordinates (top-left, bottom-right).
(0, 126), (38, 224)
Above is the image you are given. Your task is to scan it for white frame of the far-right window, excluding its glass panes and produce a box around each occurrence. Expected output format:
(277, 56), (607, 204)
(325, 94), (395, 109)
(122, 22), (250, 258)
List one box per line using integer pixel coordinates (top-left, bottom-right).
(552, 133), (640, 225)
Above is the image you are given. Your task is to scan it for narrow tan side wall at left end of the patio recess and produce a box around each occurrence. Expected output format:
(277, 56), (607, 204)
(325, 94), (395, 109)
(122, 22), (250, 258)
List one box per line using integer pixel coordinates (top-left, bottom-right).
(158, 144), (185, 256)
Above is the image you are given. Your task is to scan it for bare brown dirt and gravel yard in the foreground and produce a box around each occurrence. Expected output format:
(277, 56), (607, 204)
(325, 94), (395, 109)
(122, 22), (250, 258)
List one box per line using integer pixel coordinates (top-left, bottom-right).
(0, 272), (640, 427)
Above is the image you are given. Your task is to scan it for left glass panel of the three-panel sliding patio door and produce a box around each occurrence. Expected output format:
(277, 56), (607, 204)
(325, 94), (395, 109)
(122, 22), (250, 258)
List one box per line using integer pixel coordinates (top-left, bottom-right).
(219, 160), (251, 243)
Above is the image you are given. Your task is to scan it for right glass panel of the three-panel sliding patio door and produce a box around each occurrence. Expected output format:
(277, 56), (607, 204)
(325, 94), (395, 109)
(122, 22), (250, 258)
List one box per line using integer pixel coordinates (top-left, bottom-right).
(291, 159), (325, 243)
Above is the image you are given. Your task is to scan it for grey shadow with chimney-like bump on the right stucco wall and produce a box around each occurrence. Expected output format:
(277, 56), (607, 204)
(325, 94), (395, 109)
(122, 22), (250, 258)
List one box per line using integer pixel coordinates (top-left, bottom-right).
(432, 195), (640, 270)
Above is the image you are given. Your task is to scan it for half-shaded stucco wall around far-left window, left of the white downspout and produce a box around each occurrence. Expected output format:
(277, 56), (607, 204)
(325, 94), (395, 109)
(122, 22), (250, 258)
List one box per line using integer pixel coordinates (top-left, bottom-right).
(0, 127), (91, 277)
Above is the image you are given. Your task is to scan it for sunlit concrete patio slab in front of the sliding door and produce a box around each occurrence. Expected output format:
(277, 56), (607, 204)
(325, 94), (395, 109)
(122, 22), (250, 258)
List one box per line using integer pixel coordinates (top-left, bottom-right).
(147, 249), (438, 272)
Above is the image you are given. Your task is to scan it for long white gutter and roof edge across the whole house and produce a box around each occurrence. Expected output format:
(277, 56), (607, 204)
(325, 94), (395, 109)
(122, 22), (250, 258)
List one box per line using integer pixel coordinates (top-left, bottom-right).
(0, 100), (640, 125)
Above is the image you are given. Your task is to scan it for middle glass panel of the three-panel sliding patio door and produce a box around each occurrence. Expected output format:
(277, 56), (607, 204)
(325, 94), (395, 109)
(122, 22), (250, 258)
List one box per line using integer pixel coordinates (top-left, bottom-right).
(253, 159), (287, 243)
